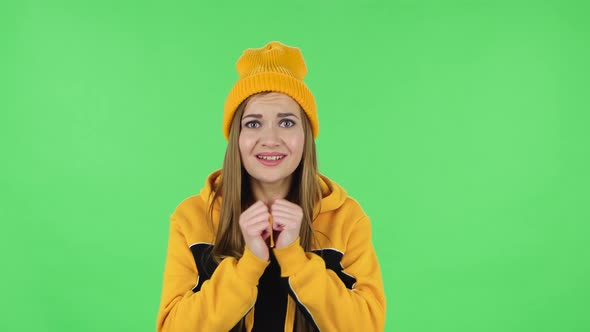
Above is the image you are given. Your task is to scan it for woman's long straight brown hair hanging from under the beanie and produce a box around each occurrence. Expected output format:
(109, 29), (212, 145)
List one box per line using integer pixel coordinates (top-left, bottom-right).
(209, 92), (322, 332)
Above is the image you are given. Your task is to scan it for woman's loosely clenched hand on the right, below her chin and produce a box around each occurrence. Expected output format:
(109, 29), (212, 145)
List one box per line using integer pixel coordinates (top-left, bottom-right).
(270, 199), (303, 249)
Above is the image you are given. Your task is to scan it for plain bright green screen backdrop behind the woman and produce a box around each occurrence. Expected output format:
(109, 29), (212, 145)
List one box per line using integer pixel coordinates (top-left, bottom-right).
(0, 0), (590, 332)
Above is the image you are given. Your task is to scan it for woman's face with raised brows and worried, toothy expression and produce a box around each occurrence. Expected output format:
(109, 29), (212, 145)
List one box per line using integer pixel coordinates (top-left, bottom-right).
(239, 92), (305, 184)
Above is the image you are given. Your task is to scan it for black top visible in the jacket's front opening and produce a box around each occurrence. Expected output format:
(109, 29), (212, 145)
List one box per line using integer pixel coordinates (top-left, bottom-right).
(252, 249), (288, 332)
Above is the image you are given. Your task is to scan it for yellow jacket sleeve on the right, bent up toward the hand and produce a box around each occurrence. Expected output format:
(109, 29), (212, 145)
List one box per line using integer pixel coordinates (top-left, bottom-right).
(274, 216), (385, 331)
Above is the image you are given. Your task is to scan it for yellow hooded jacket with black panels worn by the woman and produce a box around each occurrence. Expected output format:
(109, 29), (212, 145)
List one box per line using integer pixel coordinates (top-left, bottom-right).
(156, 170), (385, 332)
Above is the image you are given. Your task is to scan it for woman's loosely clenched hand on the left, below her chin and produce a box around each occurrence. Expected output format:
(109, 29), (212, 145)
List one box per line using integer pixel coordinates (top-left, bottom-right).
(239, 201), (272, 261)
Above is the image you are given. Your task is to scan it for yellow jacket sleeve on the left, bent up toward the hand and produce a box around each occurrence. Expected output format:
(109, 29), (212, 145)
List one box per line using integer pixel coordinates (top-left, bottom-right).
(156, 215), (269, 332)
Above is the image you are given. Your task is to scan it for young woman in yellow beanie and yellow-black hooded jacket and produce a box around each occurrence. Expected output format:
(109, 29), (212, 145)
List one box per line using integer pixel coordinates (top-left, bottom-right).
(157, 42), (385, 332)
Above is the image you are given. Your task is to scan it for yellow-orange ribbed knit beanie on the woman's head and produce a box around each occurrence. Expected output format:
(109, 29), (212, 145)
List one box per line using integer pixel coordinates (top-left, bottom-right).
(223, 41), (319, 139)
